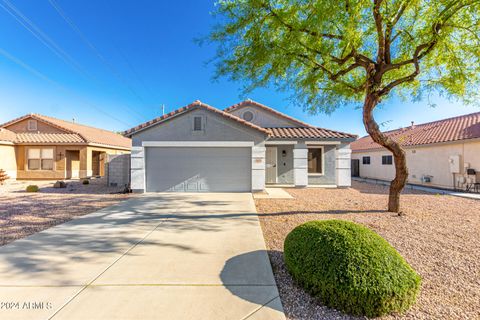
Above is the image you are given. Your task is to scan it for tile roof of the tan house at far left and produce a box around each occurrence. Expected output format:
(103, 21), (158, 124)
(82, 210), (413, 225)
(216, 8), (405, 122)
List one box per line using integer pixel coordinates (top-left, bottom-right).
(0, 114), (132, 149)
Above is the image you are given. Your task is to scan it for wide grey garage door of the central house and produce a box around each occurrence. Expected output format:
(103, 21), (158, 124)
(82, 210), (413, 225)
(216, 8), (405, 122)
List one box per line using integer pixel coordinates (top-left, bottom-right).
(145, 147), (252, 192)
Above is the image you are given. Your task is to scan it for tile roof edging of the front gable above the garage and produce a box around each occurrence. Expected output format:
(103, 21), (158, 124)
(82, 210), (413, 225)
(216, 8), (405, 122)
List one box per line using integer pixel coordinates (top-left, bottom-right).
(123, 100), (269, 137)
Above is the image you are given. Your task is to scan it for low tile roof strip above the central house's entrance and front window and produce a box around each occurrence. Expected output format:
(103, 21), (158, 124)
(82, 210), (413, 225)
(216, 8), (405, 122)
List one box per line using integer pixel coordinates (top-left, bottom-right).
(268, 127), (357, 139)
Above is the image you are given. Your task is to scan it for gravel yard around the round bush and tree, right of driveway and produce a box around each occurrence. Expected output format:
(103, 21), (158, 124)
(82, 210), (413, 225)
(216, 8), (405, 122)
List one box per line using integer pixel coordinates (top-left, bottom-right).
(255, 181), (480, 319)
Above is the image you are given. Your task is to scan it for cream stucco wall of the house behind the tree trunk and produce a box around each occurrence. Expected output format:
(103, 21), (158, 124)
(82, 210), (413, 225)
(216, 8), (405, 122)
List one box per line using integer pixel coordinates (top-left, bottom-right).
(352, 141), (480, 188)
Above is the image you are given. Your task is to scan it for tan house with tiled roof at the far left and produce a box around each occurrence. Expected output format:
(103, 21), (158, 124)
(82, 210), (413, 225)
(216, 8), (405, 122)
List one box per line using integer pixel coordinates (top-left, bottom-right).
(0, 114), (131, 180)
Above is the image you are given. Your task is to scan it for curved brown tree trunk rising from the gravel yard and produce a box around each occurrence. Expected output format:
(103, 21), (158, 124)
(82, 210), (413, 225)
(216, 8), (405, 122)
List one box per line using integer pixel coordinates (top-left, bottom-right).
(363, 93), (408, 212)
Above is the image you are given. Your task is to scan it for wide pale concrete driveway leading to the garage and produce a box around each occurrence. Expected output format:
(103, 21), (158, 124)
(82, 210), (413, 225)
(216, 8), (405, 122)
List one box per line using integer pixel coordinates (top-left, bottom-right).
(0, 193), (285, 320)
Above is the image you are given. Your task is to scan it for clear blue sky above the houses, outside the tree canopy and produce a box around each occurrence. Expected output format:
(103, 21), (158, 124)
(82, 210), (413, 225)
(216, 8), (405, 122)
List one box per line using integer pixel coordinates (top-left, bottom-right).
(0, 0), (480, 135)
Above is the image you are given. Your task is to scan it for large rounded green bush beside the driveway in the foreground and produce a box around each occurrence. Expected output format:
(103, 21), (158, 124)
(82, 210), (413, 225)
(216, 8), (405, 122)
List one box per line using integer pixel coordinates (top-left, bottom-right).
(284, 220), (421, 317)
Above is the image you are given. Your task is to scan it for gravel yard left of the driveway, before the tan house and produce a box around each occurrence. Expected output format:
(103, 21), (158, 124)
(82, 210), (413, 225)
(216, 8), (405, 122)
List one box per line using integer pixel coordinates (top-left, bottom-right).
(0, 179), (131, 246)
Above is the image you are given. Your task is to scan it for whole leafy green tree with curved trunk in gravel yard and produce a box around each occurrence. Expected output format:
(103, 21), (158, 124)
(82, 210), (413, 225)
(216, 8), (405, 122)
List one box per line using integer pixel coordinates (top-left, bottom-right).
(208, 0), (480, 212)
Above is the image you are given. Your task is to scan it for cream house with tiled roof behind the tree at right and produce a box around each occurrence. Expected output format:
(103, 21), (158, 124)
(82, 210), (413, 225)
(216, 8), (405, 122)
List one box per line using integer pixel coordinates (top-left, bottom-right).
(351, 112), (480, 188)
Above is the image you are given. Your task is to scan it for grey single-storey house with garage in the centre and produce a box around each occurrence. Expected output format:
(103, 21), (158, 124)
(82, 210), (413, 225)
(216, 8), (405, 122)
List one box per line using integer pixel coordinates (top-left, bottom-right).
(125, 100), (356, 192)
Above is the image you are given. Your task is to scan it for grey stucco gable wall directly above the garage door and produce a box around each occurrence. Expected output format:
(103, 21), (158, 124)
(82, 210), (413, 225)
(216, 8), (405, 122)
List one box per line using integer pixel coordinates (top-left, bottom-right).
(132, 110), (265, 146)
